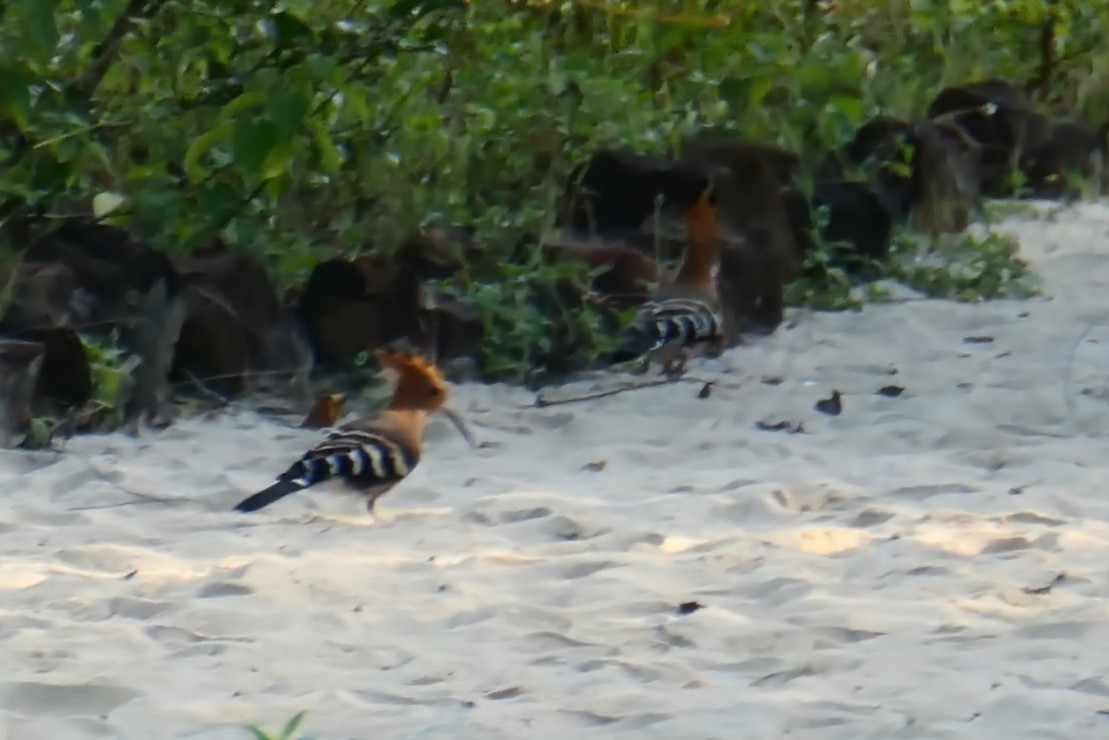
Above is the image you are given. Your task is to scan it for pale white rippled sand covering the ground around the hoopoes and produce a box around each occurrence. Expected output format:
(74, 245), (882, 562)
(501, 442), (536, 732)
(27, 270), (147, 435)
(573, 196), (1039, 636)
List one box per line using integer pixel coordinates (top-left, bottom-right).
(0, 204), (1109, 740)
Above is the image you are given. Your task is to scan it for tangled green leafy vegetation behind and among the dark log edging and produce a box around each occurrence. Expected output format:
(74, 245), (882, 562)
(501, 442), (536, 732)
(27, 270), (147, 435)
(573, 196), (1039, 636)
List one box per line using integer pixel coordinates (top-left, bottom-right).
(0, 0), (1109, 386)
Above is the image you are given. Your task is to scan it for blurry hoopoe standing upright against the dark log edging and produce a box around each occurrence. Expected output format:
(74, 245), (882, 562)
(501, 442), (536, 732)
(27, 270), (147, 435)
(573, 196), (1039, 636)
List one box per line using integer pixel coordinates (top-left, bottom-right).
(612, 179), (723, 375)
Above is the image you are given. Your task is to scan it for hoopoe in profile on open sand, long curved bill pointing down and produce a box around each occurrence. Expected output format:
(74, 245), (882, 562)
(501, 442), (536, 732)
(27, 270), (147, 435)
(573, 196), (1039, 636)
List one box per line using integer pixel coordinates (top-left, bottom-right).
(235, 349), (476, 514)
